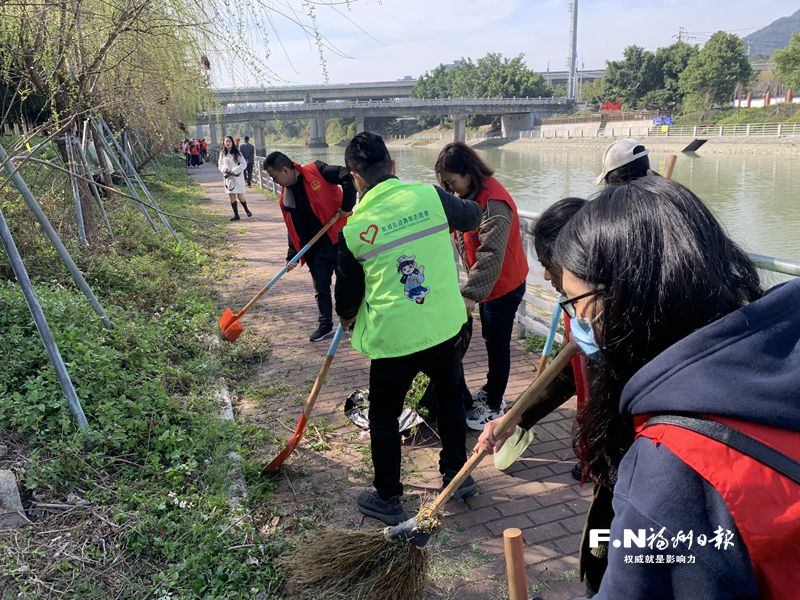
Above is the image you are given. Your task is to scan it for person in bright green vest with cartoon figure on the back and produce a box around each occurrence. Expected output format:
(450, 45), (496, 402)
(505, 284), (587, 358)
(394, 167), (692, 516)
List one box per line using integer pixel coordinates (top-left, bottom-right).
(334, 132), (481, 525)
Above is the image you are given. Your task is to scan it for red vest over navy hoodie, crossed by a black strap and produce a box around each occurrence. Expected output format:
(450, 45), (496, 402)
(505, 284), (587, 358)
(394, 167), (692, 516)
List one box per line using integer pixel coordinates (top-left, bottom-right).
(634, 415), (800, 600)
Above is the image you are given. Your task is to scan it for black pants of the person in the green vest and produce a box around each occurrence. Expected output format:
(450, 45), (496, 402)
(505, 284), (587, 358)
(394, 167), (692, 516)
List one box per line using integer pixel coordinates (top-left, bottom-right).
(369, 335), (467, 500)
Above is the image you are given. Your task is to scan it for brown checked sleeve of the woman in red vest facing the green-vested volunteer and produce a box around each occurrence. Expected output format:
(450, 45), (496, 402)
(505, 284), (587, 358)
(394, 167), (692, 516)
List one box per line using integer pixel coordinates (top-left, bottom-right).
(461, 200), (514, 302)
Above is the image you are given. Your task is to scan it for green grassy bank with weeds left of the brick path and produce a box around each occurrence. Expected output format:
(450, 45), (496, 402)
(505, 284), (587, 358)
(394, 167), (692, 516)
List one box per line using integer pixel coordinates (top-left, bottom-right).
(0, 156), (287, 599)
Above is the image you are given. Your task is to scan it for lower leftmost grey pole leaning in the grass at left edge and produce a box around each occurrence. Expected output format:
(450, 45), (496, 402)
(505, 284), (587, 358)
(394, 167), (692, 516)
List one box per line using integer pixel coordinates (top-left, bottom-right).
(0, 206), (89, 431)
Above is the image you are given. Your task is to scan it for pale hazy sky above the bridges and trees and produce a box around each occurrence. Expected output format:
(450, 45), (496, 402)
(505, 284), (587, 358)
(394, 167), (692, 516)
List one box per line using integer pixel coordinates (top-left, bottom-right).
(213, 0), (798, 87)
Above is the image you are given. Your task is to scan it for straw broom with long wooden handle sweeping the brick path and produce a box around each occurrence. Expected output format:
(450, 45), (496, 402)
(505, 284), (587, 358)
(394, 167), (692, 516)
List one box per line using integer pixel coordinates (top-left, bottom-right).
(284, 342), (578, 600)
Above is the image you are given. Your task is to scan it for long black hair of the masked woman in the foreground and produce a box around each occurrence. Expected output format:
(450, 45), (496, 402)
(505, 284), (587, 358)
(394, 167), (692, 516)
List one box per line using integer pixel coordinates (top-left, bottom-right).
(553, 177), (764, 484)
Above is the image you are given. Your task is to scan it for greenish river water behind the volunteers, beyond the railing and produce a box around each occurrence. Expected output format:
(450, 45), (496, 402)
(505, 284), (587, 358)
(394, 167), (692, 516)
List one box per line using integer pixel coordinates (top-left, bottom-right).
(260, 146), (800, 274)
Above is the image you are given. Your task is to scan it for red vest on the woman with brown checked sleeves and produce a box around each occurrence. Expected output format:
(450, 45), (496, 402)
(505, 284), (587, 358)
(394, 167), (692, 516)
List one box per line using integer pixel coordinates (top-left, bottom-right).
(464, 177), (528, 300)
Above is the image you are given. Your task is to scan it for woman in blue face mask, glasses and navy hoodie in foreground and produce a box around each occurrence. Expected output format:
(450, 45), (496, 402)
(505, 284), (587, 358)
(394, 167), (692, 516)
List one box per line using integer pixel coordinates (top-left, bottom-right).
(478, 177), (800, 599)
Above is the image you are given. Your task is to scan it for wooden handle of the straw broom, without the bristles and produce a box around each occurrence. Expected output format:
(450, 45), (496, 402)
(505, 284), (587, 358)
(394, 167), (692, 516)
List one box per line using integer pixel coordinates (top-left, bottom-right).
(428, 342), (579, 518)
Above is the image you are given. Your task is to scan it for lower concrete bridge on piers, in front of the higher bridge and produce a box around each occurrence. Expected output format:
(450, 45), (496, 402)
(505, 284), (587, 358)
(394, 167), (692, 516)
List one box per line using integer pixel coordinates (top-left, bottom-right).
(195, 97), (573, 151)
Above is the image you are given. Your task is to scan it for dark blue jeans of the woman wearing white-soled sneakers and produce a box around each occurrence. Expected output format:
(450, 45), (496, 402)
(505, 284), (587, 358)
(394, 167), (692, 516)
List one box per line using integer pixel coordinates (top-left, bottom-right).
(479, 283), (525, 410)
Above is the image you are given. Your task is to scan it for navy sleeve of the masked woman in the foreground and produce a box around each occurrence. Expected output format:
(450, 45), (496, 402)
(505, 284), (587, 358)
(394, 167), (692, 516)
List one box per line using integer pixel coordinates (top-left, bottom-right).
(594, 438), (759, 600)
